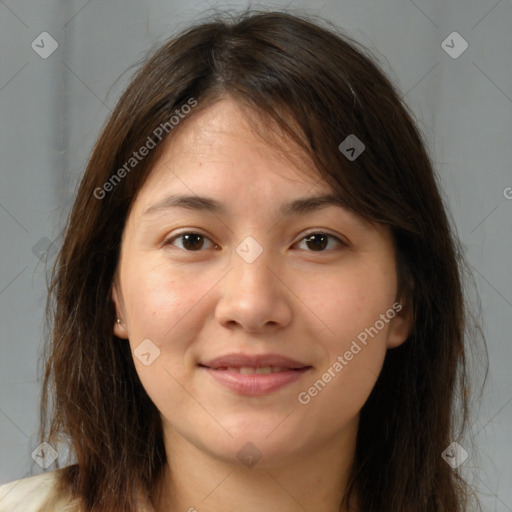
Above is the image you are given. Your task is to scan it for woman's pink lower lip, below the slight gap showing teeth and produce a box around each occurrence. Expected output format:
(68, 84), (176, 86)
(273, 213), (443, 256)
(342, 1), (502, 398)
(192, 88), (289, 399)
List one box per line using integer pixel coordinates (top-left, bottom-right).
(202, 367), (311, 396)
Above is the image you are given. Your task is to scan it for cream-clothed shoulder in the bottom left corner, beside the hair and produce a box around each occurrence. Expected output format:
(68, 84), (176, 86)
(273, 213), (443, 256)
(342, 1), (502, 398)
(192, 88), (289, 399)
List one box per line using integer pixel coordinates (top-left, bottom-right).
(0, 469), (77, 512)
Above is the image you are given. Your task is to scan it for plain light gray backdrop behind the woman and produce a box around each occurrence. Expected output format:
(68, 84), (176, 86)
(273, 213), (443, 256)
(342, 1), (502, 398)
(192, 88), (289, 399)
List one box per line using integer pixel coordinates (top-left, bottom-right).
(0, 0), (512, 512)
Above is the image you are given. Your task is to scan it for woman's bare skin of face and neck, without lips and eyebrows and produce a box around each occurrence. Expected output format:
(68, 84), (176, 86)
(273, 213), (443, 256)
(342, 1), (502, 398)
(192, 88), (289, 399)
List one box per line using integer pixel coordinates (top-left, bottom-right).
(113, 96), (410, 512)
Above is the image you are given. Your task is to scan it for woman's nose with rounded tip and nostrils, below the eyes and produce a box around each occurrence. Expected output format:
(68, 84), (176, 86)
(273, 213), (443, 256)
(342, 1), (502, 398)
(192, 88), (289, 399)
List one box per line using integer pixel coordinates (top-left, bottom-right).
(215, 242), (294, 332)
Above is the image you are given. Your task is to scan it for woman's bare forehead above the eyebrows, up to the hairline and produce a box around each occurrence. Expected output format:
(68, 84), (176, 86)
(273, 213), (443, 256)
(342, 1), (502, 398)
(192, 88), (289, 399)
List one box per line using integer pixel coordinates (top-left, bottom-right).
(132, 98), (332, 208)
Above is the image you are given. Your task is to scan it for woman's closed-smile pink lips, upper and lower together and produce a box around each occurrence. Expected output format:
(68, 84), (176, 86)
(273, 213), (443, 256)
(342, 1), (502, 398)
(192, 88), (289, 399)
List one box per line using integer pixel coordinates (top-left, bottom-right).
(199, 354), (312, 396)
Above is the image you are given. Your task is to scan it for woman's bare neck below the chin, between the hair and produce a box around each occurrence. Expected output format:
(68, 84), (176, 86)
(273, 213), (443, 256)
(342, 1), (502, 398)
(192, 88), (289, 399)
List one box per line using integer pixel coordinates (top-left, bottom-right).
(152, 418), (357, 512)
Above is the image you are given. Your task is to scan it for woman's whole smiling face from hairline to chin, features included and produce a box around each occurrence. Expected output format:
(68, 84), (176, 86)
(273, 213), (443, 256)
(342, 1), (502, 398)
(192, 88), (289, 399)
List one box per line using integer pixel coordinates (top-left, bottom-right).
(113, 97), (408, 467)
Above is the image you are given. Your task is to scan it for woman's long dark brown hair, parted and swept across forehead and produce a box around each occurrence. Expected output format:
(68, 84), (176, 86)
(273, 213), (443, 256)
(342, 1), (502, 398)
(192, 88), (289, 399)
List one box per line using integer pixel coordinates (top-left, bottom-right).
(41, 11), (484, 512)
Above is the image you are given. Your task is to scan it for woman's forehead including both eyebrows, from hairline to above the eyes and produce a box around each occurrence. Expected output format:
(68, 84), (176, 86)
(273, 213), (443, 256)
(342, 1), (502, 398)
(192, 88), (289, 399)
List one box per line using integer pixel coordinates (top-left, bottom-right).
(124, 100), (378, 236)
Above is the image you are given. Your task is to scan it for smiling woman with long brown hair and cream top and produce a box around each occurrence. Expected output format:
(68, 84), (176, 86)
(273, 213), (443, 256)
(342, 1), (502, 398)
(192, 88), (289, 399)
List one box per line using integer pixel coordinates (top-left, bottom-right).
(0, 12), (482, 512)
